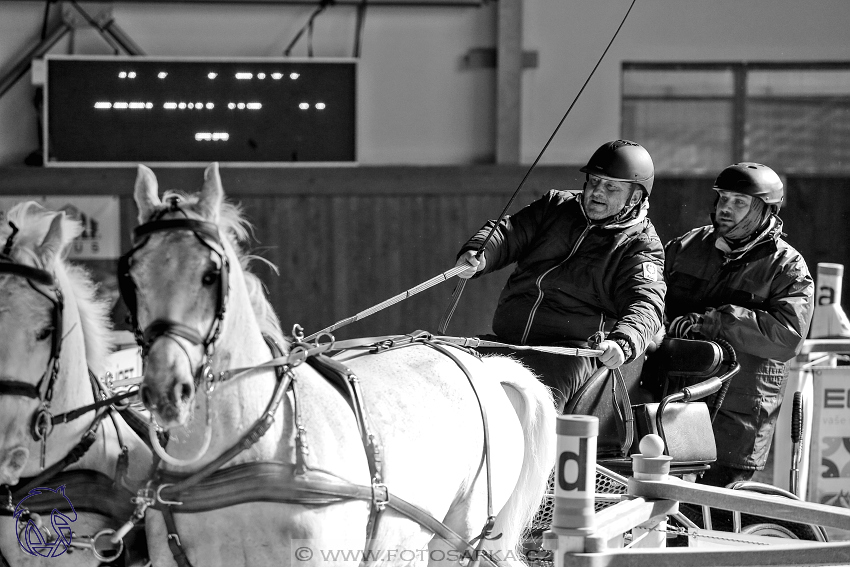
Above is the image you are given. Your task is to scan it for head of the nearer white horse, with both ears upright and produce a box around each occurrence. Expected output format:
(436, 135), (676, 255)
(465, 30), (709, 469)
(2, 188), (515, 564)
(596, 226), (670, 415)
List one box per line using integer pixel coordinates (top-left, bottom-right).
(119, 165), (229, 427)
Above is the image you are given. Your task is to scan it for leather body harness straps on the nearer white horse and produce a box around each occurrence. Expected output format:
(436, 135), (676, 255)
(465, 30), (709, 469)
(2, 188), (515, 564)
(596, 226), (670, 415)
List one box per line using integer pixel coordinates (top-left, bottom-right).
(154, 332), (510, 567)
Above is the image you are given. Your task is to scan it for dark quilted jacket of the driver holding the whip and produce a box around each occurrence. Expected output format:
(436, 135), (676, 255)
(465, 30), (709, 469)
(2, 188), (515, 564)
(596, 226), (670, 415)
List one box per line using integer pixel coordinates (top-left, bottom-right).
(459, 191), (666, 362)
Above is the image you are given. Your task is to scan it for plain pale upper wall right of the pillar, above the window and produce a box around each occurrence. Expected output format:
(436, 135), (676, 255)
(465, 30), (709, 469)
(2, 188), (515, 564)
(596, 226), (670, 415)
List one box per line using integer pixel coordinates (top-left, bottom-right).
(521, 0), (850, 164)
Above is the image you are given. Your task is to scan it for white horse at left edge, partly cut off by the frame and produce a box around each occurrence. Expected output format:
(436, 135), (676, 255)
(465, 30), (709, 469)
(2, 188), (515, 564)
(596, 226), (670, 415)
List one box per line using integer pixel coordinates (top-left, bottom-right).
(0, 202), (152, 566)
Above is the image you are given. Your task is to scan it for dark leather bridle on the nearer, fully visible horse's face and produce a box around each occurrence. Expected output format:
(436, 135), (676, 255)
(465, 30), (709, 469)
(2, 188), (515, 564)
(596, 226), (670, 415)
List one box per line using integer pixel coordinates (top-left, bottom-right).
(118, 196), (229, 379)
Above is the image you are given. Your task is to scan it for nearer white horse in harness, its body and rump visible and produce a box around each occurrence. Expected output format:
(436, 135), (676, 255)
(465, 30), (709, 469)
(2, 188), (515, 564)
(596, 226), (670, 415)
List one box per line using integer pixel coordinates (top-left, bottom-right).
(119, 164), (555, 567)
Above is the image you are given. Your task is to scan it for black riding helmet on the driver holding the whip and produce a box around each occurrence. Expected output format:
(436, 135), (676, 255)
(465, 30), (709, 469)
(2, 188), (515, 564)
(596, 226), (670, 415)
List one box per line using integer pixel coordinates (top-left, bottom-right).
(579, 140), (655, 197)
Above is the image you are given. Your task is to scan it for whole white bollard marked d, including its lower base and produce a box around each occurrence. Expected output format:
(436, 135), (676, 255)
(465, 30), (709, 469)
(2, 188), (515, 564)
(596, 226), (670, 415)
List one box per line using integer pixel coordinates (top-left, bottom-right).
(543, 415), (599, 567)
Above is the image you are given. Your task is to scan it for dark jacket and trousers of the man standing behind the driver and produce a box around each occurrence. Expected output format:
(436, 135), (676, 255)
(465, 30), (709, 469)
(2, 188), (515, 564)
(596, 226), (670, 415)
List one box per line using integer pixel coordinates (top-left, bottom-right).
(665, 217), (814, 469)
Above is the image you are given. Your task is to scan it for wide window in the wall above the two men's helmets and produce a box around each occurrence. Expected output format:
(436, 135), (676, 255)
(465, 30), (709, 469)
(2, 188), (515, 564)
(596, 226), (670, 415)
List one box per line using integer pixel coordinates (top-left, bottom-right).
(621, 62), (850, 174)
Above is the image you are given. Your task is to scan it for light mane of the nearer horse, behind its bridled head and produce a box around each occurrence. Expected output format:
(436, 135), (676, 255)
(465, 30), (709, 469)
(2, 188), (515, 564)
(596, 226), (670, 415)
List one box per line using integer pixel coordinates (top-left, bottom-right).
(161, 190), (289, 350)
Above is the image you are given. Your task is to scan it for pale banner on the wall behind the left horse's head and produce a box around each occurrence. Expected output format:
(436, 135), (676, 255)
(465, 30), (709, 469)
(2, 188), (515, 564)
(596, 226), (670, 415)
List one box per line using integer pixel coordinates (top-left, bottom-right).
(0, 195), (121, 260)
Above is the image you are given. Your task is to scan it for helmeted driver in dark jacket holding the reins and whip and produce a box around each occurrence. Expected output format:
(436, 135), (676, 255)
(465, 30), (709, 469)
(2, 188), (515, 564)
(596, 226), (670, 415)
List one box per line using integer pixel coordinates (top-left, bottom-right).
(457, 140), (666, 412)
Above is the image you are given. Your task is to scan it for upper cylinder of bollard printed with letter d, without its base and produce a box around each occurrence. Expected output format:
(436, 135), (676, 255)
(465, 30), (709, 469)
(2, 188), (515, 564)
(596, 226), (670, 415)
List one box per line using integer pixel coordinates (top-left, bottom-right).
(552, 415), (599, 530)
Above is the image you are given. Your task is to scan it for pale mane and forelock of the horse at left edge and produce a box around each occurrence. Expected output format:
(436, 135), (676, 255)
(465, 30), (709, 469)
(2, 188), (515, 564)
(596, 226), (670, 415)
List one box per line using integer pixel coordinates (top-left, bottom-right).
(0, 201), (115, 374)
